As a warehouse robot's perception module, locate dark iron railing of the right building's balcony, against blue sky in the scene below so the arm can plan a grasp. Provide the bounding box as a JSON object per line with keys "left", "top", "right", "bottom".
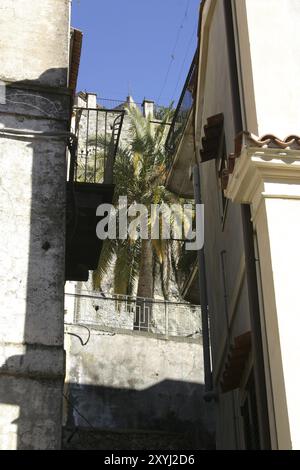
{"left": 165, "top": 54, "right": 196, "bottom": 159}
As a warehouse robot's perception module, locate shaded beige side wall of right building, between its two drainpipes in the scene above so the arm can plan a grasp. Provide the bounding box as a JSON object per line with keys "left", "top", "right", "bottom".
{"left": 197, "top": 0, "right": 251, "bottom": 449}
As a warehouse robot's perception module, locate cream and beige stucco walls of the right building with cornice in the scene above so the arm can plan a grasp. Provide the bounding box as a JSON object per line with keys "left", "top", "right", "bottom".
{"left": 197, "top": 0, "right": 300, "bottom": 449}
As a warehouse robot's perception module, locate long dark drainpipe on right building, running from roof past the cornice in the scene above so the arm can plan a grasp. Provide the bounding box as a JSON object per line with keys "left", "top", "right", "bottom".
{"left": 224, "top": 1, "right": 271, "bottom": 449}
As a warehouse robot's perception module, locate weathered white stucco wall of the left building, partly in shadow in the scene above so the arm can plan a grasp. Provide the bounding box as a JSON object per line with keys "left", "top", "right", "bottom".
{"left": 0, "top": 0, "right": 70, "bottom": 449}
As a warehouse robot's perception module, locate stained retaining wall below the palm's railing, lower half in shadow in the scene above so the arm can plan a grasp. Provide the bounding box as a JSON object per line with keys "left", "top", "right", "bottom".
{"left": 66, "top": 326, "right": 213, "bottom": 448}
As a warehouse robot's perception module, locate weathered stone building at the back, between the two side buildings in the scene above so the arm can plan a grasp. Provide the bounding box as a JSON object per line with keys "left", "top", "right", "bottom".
{"left": 64, "top": 93, "right": 214, "bottom": 450}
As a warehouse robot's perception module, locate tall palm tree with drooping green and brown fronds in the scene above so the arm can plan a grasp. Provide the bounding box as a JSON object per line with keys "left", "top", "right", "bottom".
{"left": 93, "top": 106, "right": 188, "bottom": 298}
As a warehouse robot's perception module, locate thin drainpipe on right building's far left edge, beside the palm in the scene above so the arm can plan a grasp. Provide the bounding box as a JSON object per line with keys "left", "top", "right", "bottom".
{"left": 193, "top": 165, "right": 215, "bottom": 401}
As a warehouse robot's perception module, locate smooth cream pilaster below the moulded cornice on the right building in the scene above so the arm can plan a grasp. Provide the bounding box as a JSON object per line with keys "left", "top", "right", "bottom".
{"left": 260, "top": 183, "right": 300, "bottom": 450}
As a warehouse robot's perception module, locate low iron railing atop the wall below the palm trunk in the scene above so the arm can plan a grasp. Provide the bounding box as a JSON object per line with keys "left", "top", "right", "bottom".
{"left": 66, "top": 291, "right": 201, "bottom": 338}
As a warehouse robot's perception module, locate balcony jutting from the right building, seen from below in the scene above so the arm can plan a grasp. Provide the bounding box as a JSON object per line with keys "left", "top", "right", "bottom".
{"left": 166, "top": 53, "right": 197, "bottom": 198}
